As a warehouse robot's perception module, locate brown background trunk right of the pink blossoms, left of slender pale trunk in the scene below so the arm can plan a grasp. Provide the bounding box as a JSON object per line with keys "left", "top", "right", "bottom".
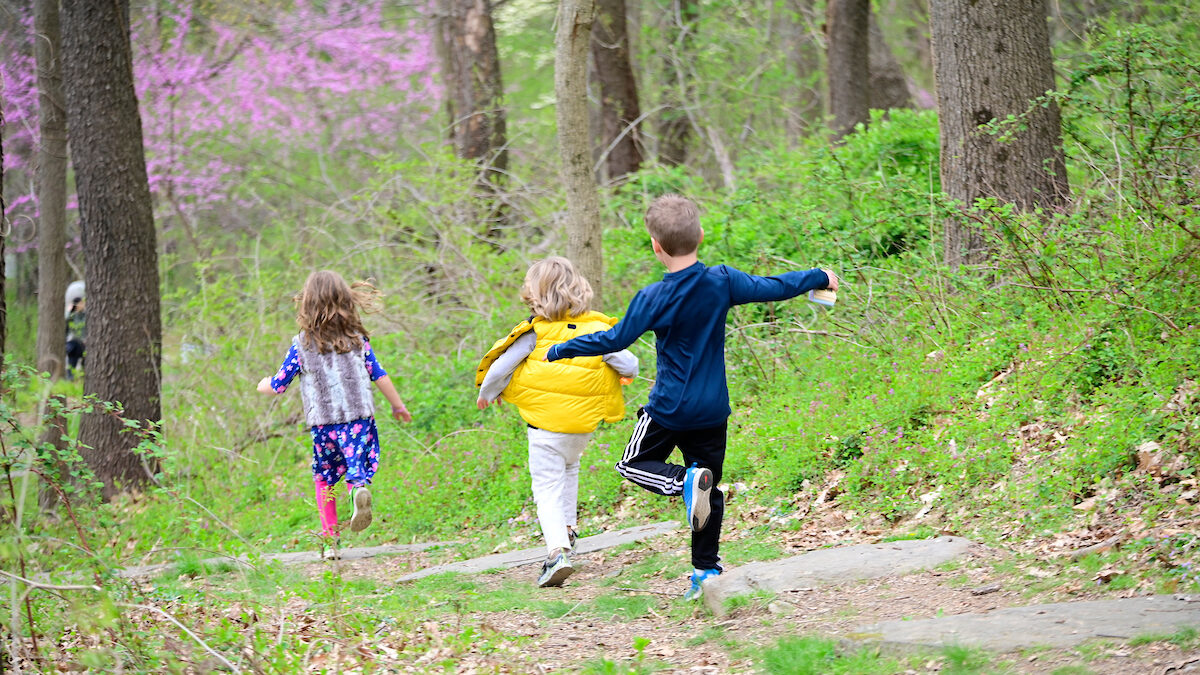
{"left": 436, "top": 0, "right": 509, "bottom": 181}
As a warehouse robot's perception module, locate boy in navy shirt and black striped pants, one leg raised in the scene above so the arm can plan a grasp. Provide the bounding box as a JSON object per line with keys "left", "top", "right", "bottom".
{"left": 546, "top": 195, "right": 838, "bottom": 599}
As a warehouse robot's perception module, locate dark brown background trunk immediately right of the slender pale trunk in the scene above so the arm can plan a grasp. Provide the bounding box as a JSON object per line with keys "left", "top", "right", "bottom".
{"left": 592, "top": 0, "right": 642, "bottom": 180}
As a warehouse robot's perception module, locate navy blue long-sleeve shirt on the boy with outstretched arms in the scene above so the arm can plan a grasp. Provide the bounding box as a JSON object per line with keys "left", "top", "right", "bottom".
{"left": 546, "top": 262, "right": 829, "bottom": 430}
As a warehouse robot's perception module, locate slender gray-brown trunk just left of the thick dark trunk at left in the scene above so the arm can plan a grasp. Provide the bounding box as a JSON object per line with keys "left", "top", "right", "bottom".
{"left": 34, "top": 0, "right": 67, "bottom": 380}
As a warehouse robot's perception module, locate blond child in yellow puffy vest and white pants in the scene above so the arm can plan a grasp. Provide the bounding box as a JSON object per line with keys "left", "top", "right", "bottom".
{"left": 475, "top": 256, "right": 637, "bottom": 586}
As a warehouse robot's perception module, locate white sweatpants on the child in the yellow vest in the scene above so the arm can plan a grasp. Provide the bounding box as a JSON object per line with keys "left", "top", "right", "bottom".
{"left": 529, "top": 426, "right": 592, "bottom": 554}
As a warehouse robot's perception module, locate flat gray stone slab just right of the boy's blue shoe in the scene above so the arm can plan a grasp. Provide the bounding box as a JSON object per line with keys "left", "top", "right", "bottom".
{"left": 702, "top": 537, "right": 971, "bottom": 616}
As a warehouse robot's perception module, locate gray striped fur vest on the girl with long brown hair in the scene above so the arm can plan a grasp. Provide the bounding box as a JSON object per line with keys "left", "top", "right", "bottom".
{"left": 292, "top": 333, "right": 374, "bottom": 426}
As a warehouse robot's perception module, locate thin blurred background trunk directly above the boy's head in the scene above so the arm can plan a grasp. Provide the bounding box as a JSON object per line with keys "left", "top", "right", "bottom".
{"left": 659, "top": 0, "right": 700, "bottom": 167}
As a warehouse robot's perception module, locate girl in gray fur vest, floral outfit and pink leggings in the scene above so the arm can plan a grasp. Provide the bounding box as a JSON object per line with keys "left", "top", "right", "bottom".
{"left": 258, "top": 270, "right": 413, "bottom": 557}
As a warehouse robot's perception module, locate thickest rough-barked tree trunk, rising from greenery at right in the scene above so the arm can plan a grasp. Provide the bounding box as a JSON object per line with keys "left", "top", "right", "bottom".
{"left": 930, "top": 0, "right": 1069, "bottom": 265}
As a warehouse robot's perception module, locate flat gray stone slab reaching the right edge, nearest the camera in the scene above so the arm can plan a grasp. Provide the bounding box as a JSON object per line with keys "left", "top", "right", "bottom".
{"left": 848, "top": 596, "right": 1200, "bottom": 652}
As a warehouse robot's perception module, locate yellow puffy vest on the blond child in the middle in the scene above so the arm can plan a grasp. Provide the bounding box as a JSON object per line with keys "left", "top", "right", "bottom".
{"left": 475, "top": 311, "right": 625, "bottom": 434}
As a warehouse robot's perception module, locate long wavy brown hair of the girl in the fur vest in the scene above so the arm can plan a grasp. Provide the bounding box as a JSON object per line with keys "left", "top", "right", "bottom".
{"left": 294, "top": 269, "right": 379, "bottom": 354}
